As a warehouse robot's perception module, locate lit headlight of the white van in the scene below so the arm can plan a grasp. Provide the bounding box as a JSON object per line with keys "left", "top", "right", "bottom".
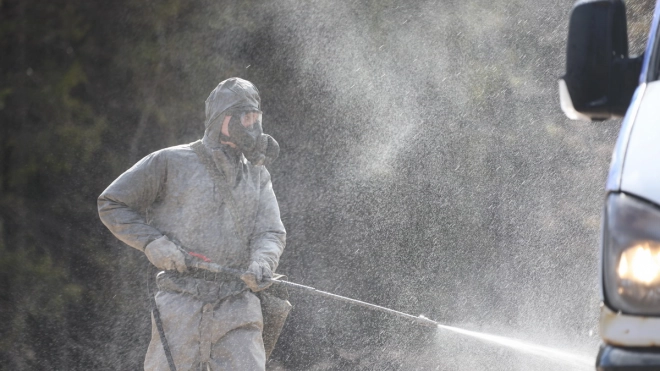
{"left": 602, "top": 193, "right": 660, "bottom": 315}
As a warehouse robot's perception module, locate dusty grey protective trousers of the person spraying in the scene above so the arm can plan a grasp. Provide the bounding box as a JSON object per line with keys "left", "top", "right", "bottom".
{"left": 144, "top": 291, "right": 266, "bottom": 371}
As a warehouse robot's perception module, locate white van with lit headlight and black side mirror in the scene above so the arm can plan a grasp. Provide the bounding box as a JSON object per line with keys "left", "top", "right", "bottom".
{"left": 559, "top": 0, "right": 660, "bottom": 370}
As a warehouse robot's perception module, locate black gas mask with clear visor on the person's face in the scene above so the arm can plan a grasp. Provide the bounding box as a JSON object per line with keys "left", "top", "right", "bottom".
{"left": 220, "top": 112, "right": 280, "bottom": 166}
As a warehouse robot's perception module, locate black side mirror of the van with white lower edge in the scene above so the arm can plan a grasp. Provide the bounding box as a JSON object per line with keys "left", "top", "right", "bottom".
{"left": 559, "top": 0, "right": 642, "bottom": 121}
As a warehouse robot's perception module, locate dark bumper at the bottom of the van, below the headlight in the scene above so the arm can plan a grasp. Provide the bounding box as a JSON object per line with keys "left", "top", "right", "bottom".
{"left": 596, "top": 345, "right": 660, "bottom": 371}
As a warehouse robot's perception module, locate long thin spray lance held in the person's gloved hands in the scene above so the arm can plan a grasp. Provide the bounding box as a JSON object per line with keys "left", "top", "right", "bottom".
{"left": 186, "top": 251, "right": 440, "bottom": 328}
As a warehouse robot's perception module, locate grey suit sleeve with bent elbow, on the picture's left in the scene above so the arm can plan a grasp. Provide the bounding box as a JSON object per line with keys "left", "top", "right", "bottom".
{"left": 98, "top": 151, "right": 167, "bottom": 251}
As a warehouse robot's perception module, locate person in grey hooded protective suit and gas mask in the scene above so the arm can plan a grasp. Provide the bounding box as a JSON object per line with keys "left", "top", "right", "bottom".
{"left": 98, "top": 78, "right": 286, "bottom": 370}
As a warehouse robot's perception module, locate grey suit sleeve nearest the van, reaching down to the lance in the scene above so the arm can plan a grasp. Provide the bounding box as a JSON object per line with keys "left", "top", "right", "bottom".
{"left": 250, "top": 167, "right": 286, "bottom": 271}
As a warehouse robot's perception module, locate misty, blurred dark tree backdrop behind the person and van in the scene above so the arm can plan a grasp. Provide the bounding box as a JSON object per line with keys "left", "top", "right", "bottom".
{"left": 0, "top": 0, "right": 653, "bottom": 370}
